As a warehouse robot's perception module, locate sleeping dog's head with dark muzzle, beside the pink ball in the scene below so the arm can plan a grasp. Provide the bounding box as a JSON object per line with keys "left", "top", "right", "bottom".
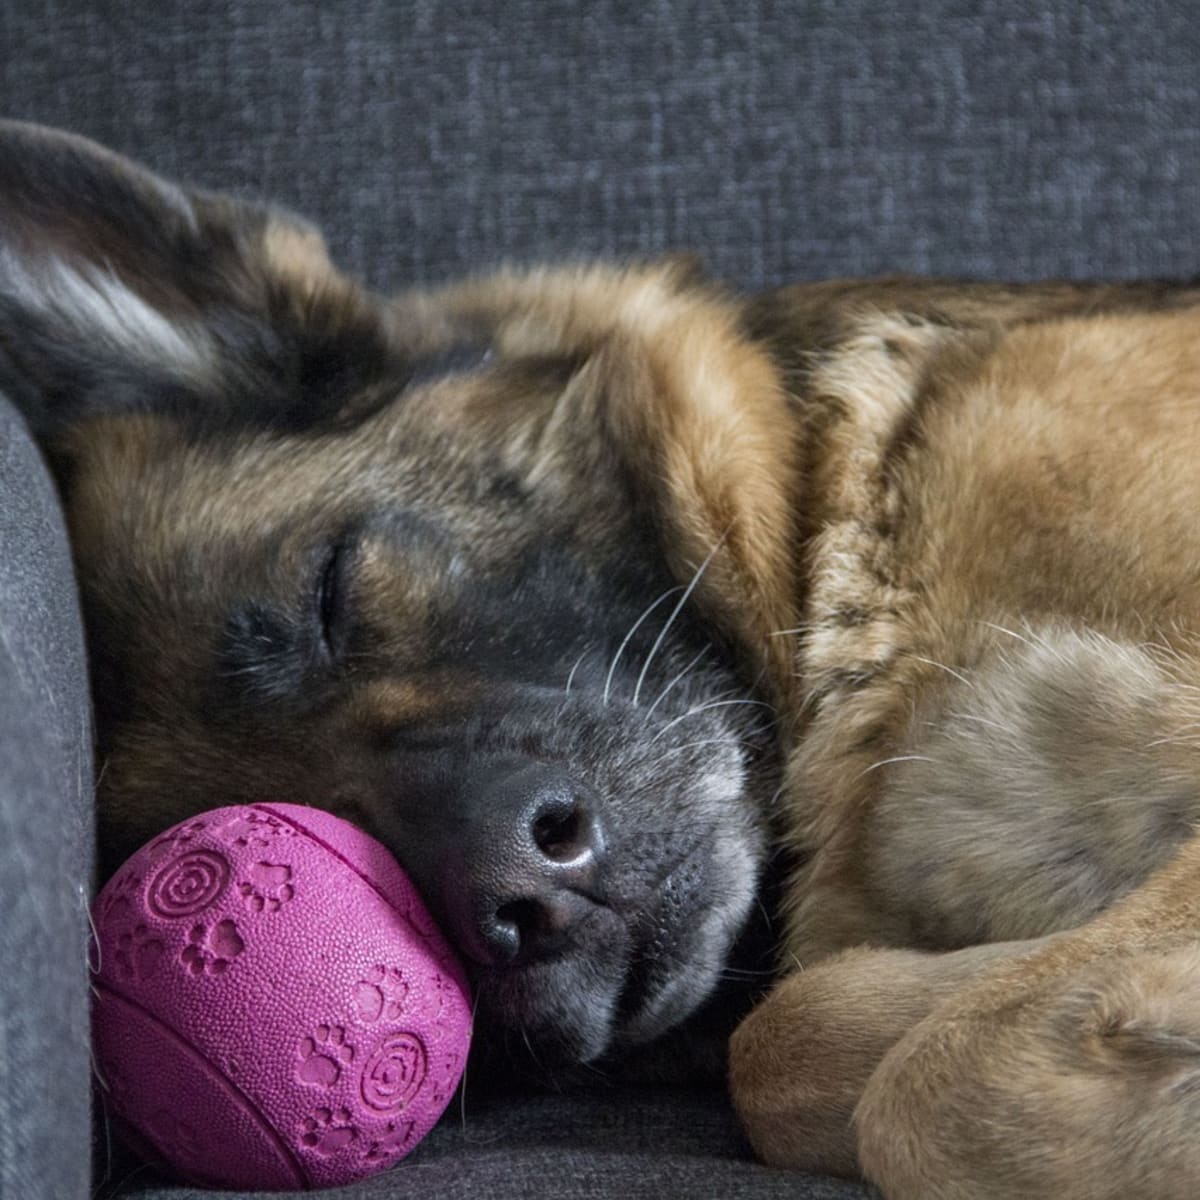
{"left": 0, "top": 125, "right": 793, "bottom": 1061}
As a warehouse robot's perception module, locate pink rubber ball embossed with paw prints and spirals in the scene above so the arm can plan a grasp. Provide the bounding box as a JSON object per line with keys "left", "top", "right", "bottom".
{"left": 92, "top": 804, "right": 470, "bottom": 1189}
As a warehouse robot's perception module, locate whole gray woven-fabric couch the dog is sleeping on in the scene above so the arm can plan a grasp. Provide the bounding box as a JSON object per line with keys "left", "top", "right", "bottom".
{"left": 0, "top": 0, "right": 1200, "bottom": 1200}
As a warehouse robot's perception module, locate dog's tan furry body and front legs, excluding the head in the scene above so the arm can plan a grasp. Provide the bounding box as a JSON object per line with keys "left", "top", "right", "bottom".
{"left": 732, "top": 285, "right": 1200, "bottom": 1200}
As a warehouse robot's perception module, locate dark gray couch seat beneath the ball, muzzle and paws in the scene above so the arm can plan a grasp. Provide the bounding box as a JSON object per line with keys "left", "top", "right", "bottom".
{"left": 100, "top": 1090, "right": 878, "bottom": 1200}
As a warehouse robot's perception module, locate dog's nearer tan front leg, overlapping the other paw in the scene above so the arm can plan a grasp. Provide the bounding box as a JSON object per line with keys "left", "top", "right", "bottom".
{"left": 854, "top": 839, "right": 1200, "bottom": 1200}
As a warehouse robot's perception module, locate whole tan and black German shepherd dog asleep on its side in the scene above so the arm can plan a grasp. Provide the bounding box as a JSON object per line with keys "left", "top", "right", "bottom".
{"left": 7, "top": 124, "right": 1200, "bottom": 1200}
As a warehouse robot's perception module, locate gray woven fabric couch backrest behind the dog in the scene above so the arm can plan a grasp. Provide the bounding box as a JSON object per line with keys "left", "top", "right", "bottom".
{"left": 0, "top": 0, "right": 1200, "bottom": 288}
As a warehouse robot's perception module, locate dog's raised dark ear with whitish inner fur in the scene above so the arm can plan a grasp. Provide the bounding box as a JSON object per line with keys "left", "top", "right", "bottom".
{"left": 0, "top": 121, "right": 403, "bottom": 434}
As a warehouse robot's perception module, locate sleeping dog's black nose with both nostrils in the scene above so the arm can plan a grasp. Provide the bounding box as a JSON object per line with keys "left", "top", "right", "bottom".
{"left": 450, "top": 763, "right": 605, "bottom": 966}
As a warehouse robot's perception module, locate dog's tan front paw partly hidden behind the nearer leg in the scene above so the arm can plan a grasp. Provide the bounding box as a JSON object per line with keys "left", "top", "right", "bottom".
{"left": 730, "top": 941, "right": 1040, "bottom": 1176}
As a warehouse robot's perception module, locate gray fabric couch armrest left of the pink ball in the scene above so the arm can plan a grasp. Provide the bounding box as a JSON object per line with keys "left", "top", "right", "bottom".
{"left": 0, "top": 397, "right": 91, "bottom": 1200}
